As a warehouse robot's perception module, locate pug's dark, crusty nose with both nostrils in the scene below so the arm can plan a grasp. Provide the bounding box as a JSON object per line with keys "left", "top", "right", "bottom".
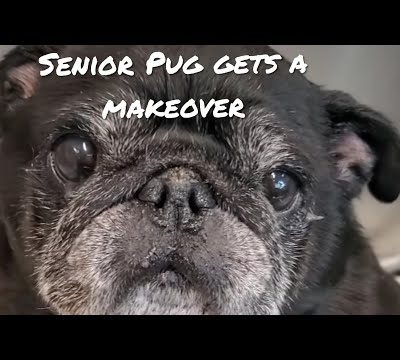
{"left": 138, "top": 168, "right": 216, "bottom": 225}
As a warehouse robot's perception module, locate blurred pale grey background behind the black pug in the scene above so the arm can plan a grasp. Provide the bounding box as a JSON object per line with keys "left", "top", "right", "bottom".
{"left": 0, "top": 45, "right": 400, "bottom": 281}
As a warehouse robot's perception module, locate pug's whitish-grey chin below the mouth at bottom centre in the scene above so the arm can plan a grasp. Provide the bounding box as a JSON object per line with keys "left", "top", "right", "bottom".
{"left": 109, "top": 270, "right": 211, "bottom": 315}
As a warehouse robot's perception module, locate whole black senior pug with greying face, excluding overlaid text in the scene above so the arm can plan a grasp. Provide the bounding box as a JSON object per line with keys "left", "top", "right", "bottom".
{"left": 0, "top": 45, "right": 400, "bottom": 315}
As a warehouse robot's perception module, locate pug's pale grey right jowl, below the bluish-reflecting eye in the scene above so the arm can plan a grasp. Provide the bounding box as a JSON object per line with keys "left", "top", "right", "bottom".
{"left": 198, "top": 211, "right": 276, "bottom": 314}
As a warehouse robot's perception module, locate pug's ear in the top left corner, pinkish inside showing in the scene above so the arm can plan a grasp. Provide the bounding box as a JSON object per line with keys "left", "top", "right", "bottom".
{"left": 0, "top": 45, "right": 62, "bottom": 111}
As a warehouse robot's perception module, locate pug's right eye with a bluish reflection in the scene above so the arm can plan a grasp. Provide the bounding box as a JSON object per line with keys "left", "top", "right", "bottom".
{"left": 264, "top": 170, "right": 300, "bottom": 211}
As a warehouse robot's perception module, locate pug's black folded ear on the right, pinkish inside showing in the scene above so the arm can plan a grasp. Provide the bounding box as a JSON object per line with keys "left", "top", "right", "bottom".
{"left": 323, "top": 91, "right": 400, "bottom": 203}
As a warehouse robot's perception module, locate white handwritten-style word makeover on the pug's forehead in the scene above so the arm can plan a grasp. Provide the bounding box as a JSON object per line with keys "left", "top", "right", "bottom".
{"left": 102, "top": 99, "right": 245, "bottom": 119}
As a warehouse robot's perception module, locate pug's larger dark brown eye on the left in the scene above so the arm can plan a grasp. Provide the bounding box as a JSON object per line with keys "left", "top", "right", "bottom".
{"left": 52, "top": 135, "right": 96, "bottom": 182}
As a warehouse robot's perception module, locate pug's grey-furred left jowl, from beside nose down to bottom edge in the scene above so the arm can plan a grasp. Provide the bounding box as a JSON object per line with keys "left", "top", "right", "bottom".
{"left": 37, "top": 204, "right": 161, "bottom": 314}
